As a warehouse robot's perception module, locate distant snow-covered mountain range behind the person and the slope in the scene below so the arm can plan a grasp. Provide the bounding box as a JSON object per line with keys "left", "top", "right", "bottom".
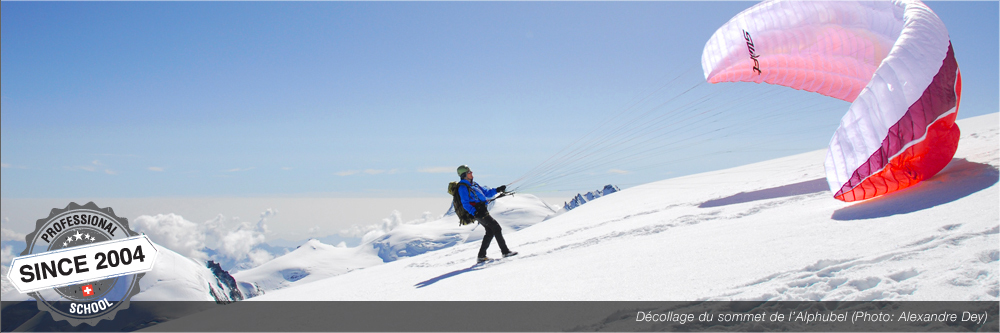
{"left": 2, "top": 185, "right": 619, "bottom": 304}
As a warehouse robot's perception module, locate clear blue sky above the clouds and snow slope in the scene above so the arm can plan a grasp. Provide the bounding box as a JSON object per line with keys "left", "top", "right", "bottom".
{"left": 0, "top": 1, "right": 1000, "bottom": 198}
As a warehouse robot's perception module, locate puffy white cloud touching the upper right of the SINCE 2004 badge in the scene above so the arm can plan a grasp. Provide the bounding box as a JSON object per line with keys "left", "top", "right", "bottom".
{"left": 132, "top": 214, "right": 208, "bottom": 260}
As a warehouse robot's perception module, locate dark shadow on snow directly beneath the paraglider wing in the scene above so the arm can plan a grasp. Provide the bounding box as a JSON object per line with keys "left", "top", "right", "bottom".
{"left": 831, "top": 158, "right": 1000, "bottom": 221}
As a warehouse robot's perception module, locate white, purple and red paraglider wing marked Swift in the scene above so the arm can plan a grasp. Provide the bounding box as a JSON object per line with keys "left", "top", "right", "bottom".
{"left": 701, "top": 0, "right": 962, "bottom": 201}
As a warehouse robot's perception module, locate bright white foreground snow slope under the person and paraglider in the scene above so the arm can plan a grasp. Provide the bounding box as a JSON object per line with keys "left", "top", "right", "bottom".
{"left": 251, "top": 114, "right": 1000, "bottom": 301}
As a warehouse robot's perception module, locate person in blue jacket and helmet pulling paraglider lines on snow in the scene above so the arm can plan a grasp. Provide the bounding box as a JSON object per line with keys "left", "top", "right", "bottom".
{"left": 458, "top": 165, "right": 517, "bottom": 262}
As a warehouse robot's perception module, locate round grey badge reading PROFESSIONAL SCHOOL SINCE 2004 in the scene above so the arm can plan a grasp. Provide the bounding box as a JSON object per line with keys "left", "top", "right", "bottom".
{"left": 9, "top": 202, "right": 156, "bottom": 326}
